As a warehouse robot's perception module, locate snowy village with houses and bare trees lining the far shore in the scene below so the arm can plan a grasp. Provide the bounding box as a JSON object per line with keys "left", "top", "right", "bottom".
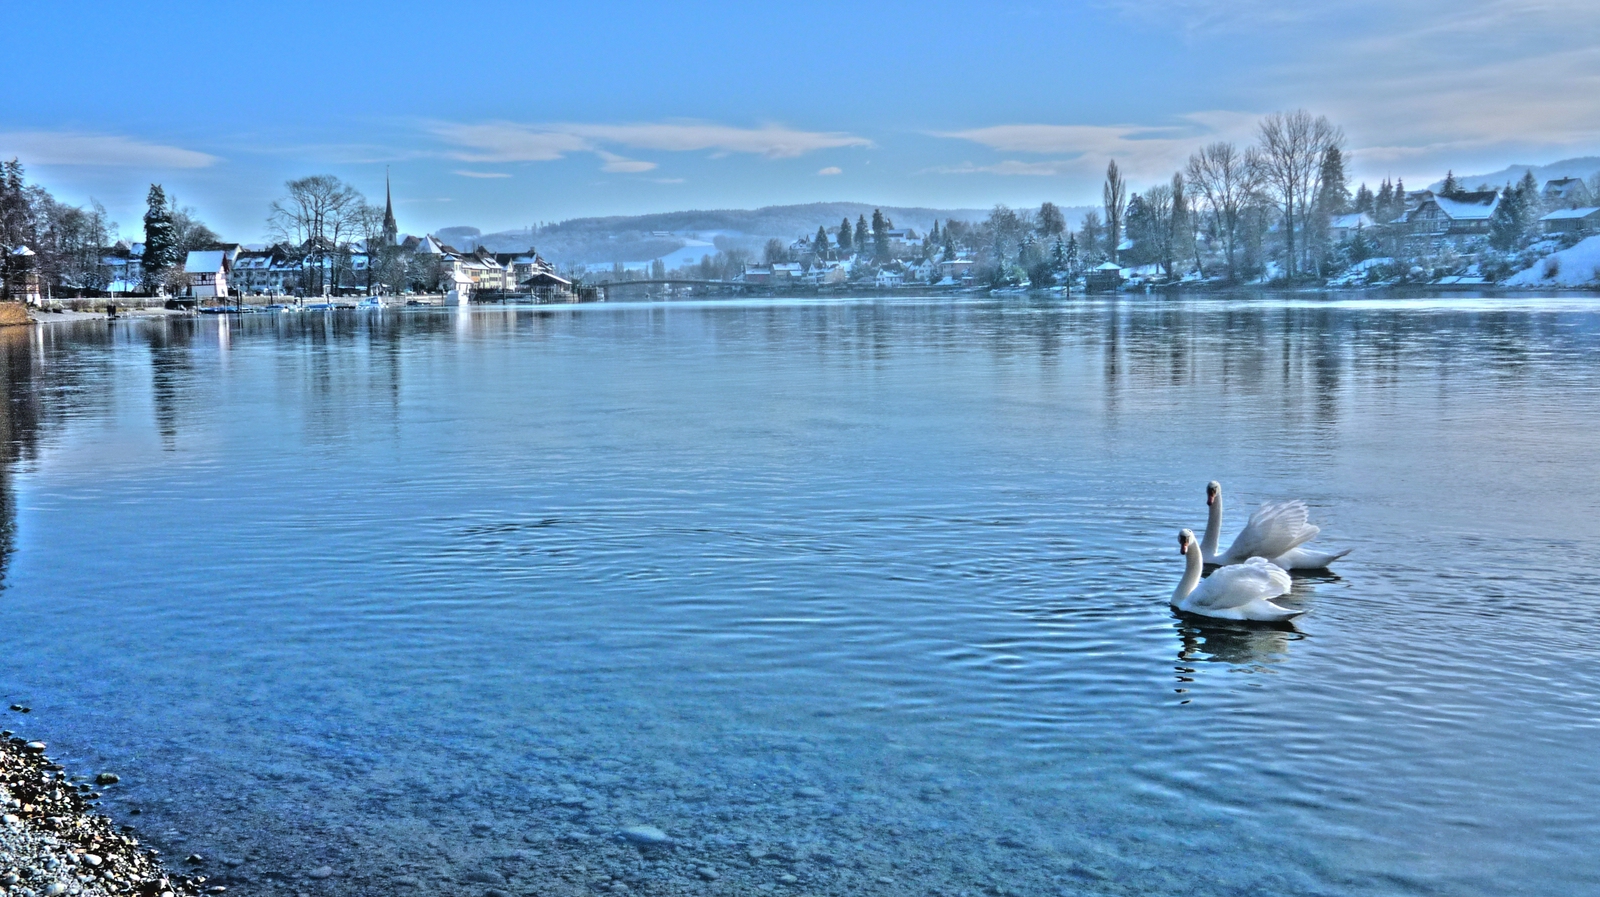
{"left": 0, "top": 110, "right": 1600, "bottom": 312}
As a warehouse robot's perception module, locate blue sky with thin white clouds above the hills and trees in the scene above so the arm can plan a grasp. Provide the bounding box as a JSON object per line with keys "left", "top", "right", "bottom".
{"left": 0, "top": 0, "right": 1600, "bottom": 241}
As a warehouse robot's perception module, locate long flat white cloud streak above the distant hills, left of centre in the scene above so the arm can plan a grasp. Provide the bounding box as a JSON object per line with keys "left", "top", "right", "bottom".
{"left": 430, "top": 122, "right": 872, "bottom": 173}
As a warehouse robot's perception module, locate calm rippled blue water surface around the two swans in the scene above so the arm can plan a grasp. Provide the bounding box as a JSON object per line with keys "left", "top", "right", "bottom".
{"left": 0, "top": 297, "right": 1600, "bottom": 895}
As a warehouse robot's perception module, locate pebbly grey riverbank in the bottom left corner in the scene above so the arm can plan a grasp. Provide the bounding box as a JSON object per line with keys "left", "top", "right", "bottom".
{"left": 0, "top": 731, "right": 201, "bottom": 897}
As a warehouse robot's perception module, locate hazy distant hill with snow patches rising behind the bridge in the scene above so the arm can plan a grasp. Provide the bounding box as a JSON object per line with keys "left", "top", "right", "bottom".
{"left": 440, "top": 203, "right": 1090, "bottom": 267}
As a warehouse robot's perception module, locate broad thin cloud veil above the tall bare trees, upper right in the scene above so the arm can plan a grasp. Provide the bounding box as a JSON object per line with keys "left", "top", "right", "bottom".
{"left": 1101, "top": 0, "right": 1600, "bottom": 174}
